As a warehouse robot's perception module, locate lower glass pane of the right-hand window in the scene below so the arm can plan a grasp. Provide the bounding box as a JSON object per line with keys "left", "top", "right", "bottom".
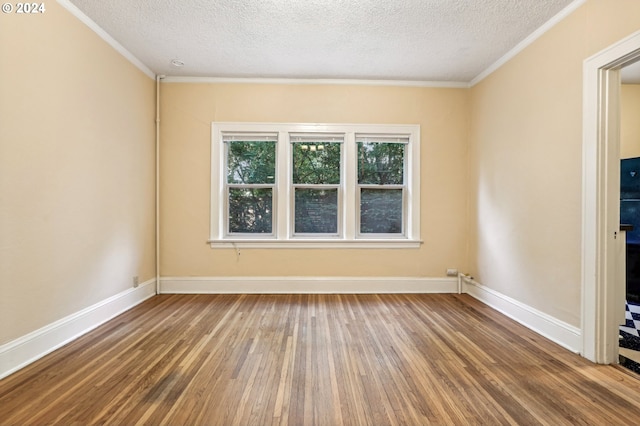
{"left": 360, "top": 188, "right": 402, "bottom": 234}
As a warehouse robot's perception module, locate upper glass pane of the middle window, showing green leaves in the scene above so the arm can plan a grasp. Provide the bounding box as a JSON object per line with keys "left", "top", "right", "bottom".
{"left": 292, "top": 142, "right": 342, "bottom": 185}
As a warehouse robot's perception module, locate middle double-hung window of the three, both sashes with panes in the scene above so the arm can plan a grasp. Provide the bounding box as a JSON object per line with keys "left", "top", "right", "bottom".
{"left": 289, "top": 134, "right": 344, "bottom": 238}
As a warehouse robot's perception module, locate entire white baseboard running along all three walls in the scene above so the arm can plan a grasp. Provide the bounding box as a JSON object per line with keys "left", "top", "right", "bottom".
{"left": 0, "top": 277, "right": 582, "bottom": 379}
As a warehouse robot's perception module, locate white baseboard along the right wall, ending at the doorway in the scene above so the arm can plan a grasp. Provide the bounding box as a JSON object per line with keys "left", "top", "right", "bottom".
{"left": 463, "top": 278, "right": 582, "bottom": 353}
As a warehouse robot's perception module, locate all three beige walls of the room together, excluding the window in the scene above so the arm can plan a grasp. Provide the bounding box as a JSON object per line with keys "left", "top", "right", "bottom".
{"left": 5, "top": 0, "right": 640, "bottom": 350}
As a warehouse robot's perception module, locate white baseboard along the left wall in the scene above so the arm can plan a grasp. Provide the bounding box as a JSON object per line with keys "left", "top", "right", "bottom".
{"left": 0, "top": 278, "right": 156, "bottom": 379}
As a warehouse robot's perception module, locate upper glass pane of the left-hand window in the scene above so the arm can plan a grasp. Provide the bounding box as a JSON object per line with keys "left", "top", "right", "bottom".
{"left": 227, "top": 141, "right": 276, "bottom": 184}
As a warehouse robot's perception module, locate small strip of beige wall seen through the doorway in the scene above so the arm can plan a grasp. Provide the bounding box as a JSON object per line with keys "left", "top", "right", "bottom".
{"left": 620, "top": 84, "right": 640, "bottom": 158}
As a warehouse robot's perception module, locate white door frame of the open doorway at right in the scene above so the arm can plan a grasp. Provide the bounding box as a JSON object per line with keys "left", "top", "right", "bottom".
{"left": 581, "top": 31, "right": 640, "bottom": 364}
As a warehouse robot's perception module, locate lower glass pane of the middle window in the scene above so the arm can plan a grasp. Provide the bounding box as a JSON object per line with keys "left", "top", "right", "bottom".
{"left": 294, "top": 188, "right": 338, "bottom": 234}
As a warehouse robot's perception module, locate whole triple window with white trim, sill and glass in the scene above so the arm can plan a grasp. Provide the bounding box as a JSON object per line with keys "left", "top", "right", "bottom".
{"left": 209, "top": 123, "right": 420, "bottom": 248}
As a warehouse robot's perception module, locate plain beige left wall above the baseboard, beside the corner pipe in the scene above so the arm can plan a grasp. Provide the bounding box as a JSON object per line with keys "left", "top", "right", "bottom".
{"left": 0, "top": 2, "right": 155, "bottom": 344}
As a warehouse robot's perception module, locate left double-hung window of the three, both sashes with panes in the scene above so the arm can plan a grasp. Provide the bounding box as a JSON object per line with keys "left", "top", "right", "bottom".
{"left": 223, "top": 134, "right": 277, "bottom": 236}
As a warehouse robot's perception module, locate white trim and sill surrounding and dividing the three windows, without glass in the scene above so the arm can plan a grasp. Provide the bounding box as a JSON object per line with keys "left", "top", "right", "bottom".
{"left": 208, "top": 122, "right": 422, "bottom": 248}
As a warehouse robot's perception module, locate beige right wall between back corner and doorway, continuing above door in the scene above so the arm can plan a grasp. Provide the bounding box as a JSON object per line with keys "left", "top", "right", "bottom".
{"left": 470, "top": 0, "right": 640, "bottom": 326}
